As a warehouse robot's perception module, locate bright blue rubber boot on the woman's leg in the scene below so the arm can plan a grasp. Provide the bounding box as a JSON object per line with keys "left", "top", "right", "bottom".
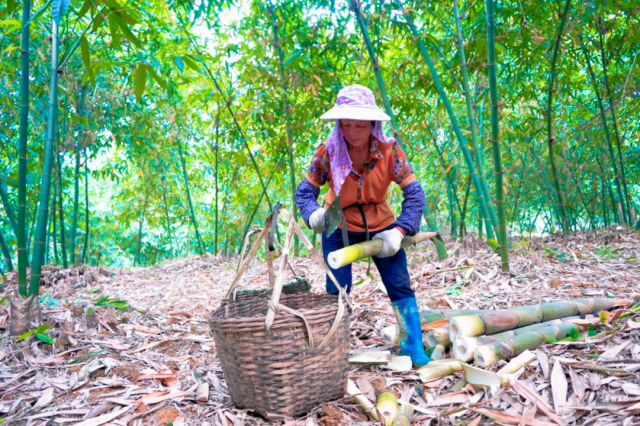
{"left": 393, "top": 297, "right": 431, "bottom": 367}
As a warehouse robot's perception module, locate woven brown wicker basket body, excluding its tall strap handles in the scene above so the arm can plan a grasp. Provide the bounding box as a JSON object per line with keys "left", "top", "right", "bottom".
{"left": 209, "top": 294, "right": 349, "bottom": 418}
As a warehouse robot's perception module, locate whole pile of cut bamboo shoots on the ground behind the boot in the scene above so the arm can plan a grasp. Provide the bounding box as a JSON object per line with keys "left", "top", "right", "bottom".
{"left": 382, "top": 298, "right": 633, "bottom": 367}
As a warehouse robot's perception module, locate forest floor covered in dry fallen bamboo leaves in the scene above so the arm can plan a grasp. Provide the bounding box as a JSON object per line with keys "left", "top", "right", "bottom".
{"left": 0, "top": 229, "right": 640, "bottom": 426}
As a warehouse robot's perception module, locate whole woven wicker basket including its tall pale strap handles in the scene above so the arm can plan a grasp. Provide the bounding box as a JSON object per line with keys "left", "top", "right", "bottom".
{"left": 209, "top": 209, "right": 350, "bottom": 419}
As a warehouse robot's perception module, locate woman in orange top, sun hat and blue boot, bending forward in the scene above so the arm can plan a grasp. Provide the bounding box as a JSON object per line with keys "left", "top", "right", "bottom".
{"left": 296, "top": 84, "right": 431, "bottom": 366}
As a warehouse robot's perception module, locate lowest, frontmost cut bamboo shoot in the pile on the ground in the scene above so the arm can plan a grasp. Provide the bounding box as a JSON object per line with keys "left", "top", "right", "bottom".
{"left": 474, "top": 323, "right": 579, "bottom": 368}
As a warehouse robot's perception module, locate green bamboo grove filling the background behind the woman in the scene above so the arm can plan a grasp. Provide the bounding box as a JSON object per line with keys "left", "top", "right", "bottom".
{"left": 0, "top": 0, "right": 640, "bottom": 290}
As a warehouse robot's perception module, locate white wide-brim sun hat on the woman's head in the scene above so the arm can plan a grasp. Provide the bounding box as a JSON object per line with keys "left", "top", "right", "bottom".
{"left": 320, "top": 84, "right": 391, "bottom": 121}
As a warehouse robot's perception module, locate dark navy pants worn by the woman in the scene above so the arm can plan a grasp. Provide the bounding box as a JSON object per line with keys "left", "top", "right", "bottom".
{"left": 322, "top": 225, "right": 415, "bottom": 302}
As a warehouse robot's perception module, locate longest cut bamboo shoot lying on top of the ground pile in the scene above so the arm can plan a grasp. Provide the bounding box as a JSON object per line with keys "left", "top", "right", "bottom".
{"left": 449, "top": 298, "right": 633, "bottom": 341}
